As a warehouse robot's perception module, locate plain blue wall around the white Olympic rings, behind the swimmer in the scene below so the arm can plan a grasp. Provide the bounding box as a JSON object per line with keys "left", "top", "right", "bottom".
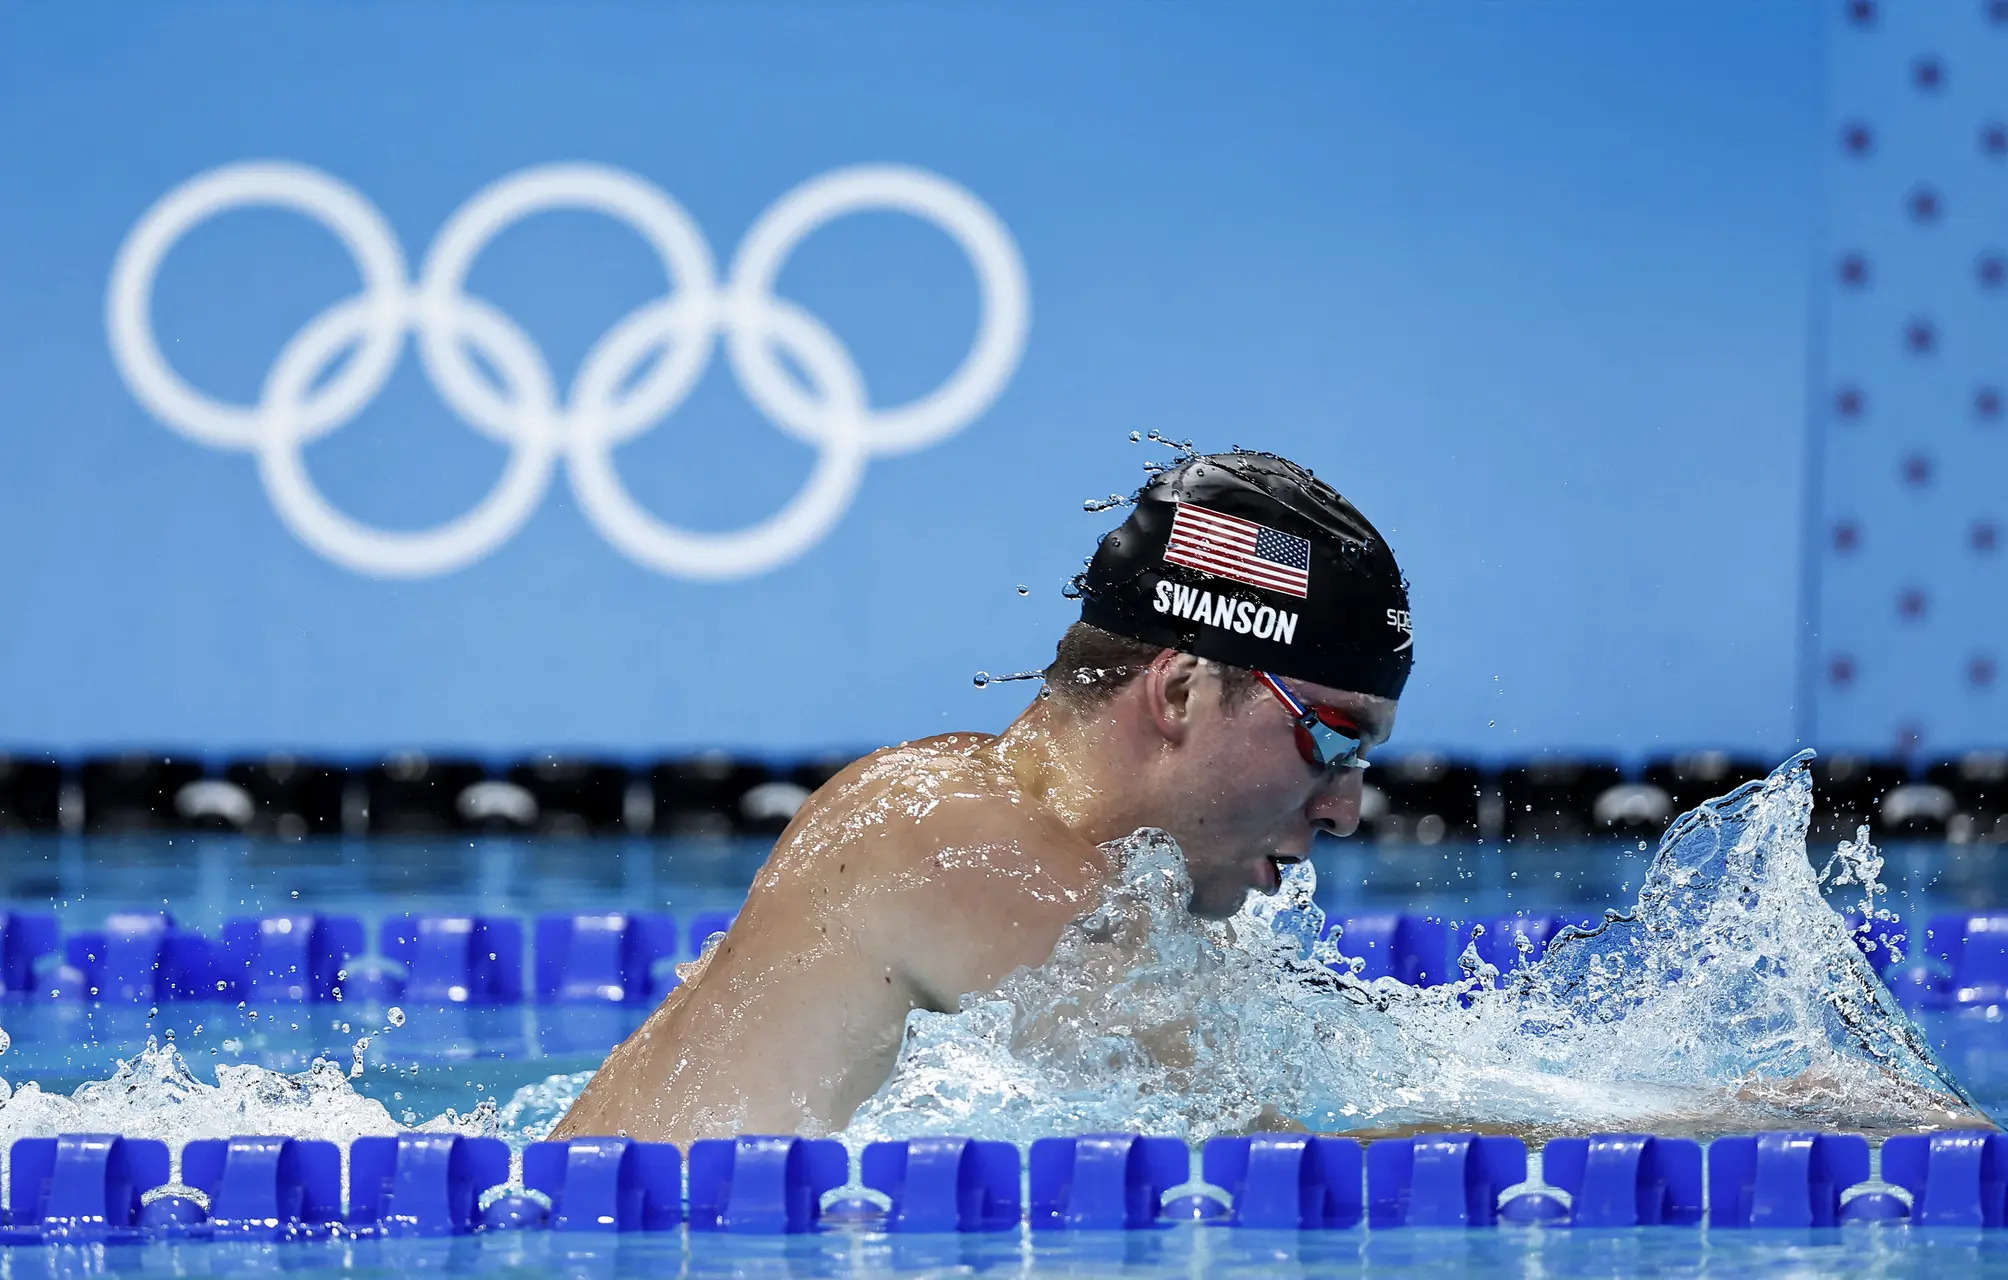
{"left": 0, "top": 0, "right": 1998, "bottom": 758}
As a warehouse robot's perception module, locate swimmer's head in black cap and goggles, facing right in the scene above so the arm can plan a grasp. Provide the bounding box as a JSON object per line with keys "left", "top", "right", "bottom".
{"left": 1046, "top": 452, "right": 1412, "bottom": 916}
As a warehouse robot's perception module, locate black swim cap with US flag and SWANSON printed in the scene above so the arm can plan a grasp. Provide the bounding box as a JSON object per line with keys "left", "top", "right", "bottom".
{"left": 1076, "top": 450, "right": 1416, "bottom": 697}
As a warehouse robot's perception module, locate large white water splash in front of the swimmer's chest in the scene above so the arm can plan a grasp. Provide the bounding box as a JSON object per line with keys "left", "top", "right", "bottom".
{"left": 845, "top": 752, "right": 1972, "bottom": 1141}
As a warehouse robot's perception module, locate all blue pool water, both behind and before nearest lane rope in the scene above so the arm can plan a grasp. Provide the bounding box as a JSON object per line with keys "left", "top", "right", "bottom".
{"left": 0, "top": 823, "right": 2008, "bottom": 1280}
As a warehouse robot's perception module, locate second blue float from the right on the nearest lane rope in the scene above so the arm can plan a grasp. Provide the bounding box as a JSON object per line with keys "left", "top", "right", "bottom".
{"left": 1709, "top": 1133, "right": 1869, "bottom": 1228}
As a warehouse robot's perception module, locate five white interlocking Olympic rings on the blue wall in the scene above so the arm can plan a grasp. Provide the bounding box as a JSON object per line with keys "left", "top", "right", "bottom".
{"left": 106, "top": 163, "right": 1030, "bottom": 579}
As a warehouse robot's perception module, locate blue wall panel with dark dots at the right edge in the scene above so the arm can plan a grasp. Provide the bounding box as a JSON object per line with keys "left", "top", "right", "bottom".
{"left": 1803, "top": 2, "right": 2008, "bottom": 754}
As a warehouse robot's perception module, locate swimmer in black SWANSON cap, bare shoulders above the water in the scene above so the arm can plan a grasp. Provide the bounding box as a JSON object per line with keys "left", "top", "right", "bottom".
{"left": 552, "top": 452, "right": 1414, "bottom": 1145}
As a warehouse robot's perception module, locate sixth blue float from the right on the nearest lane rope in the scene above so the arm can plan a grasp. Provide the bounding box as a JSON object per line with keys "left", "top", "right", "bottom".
{"left": 1030, "top": 1133, "right": 1193, "bottom": 1232}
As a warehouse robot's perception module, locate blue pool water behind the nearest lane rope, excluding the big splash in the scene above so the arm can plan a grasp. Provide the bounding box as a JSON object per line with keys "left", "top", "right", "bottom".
{"left": 0, "top": 836, "right": 2008, "bottom": 1121}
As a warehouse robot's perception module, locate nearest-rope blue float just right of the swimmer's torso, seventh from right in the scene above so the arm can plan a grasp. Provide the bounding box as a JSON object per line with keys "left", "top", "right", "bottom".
{"left": 859, "top": 1137, "right": 1022, "bottom": 1232}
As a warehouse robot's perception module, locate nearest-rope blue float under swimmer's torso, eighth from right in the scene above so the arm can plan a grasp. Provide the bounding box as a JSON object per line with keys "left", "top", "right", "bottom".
{"left": 691, "top": 1135, "right": 851, "bottom": 1236}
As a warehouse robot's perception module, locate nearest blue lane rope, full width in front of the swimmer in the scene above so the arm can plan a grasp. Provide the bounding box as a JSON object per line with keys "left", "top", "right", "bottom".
{"left": 0, "top": 1129, "right": 2008, "bottom": 1246}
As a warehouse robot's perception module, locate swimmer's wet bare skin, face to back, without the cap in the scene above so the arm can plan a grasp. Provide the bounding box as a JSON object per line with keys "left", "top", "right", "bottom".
{"left": 552, "top": 651, "right": 1396, "bottom": 1143}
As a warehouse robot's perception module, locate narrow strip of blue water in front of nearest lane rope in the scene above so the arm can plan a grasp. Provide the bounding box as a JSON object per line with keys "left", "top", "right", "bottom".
{"left": 11, "top": 1226, "right": 2008, "bottom": 1280}
